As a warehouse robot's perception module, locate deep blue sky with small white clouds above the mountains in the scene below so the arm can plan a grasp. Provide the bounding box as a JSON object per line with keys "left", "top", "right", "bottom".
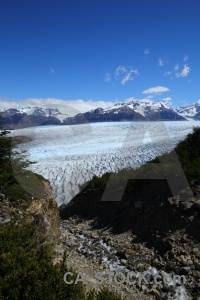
{"left": 0, "top": 0, "right": 200, "bottom": 110}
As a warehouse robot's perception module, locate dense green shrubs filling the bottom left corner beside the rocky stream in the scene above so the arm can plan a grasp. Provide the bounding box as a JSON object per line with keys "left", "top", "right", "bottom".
{"left": 0, "top": 217, "right": 120, "bottom": 300}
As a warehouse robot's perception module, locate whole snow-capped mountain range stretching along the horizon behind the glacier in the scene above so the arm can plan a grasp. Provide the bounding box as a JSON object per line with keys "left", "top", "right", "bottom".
{"left": 0, "top": 100, "right": 200, "bottom": 129}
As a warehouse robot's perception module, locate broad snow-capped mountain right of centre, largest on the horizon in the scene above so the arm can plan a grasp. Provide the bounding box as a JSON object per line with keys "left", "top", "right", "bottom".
{"left": 63, "top": 100, "right": 185, "bottom": 125}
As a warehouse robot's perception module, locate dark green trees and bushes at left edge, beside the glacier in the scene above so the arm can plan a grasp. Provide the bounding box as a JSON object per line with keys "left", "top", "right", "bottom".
{"left": 0, "top": 126, "right": 45, "bottom": 202}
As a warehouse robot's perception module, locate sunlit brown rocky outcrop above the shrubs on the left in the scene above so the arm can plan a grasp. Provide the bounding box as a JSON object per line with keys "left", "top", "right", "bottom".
{"left": 0, "top": 180, "right": 60, "bottom": 245}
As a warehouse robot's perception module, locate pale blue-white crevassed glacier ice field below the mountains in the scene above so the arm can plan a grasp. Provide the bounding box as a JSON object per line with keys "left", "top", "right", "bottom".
{"left": 12, "top": 121, "right": 200, "bottom": 205}
